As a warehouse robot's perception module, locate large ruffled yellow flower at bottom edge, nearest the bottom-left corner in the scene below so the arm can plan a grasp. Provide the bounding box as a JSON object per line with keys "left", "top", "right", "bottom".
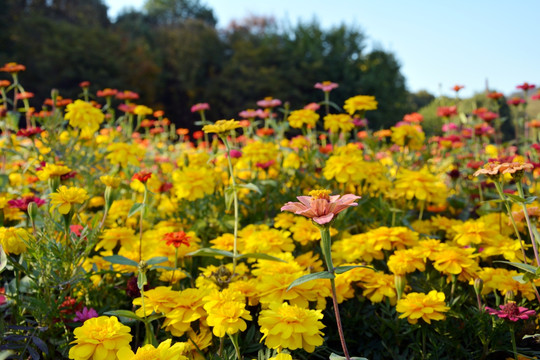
{"left": 69, "top": 316, "right": 132, "bottom": 360}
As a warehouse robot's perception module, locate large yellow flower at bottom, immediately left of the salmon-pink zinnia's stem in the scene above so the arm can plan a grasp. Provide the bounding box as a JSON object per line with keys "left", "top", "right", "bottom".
{"left": 259, "top": 303, "right": 324, "bottom": 352}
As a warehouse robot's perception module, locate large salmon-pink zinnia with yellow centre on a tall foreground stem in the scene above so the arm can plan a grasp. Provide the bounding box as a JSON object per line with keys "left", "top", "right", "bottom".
{"left": 281, "top": 190, "right": 360, "bottom": 225}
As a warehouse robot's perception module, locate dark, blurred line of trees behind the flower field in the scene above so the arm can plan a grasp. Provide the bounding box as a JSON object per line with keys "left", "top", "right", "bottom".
{"left": 0, "top": 0, "right": 431, "bottom": 128}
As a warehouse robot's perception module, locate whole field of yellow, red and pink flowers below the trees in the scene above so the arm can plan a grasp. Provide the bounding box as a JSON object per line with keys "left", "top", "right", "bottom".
{"left": 0, "top": 63, "right": 540, "bottom": 360}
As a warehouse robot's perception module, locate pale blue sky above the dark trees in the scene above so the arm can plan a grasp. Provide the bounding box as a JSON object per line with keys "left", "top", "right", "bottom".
{"left": 104, "top": 0, "right": 540, "bottom": 96}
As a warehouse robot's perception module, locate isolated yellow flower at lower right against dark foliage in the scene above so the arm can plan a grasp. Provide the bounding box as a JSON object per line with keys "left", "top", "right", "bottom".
{"left": 396, "top": 290, "right": 450, "bottom": 324}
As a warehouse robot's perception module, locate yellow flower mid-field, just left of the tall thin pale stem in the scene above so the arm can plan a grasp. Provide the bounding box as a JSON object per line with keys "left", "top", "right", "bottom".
{"left": 172, "top": 166, "right": 216, "bottom": 201}
